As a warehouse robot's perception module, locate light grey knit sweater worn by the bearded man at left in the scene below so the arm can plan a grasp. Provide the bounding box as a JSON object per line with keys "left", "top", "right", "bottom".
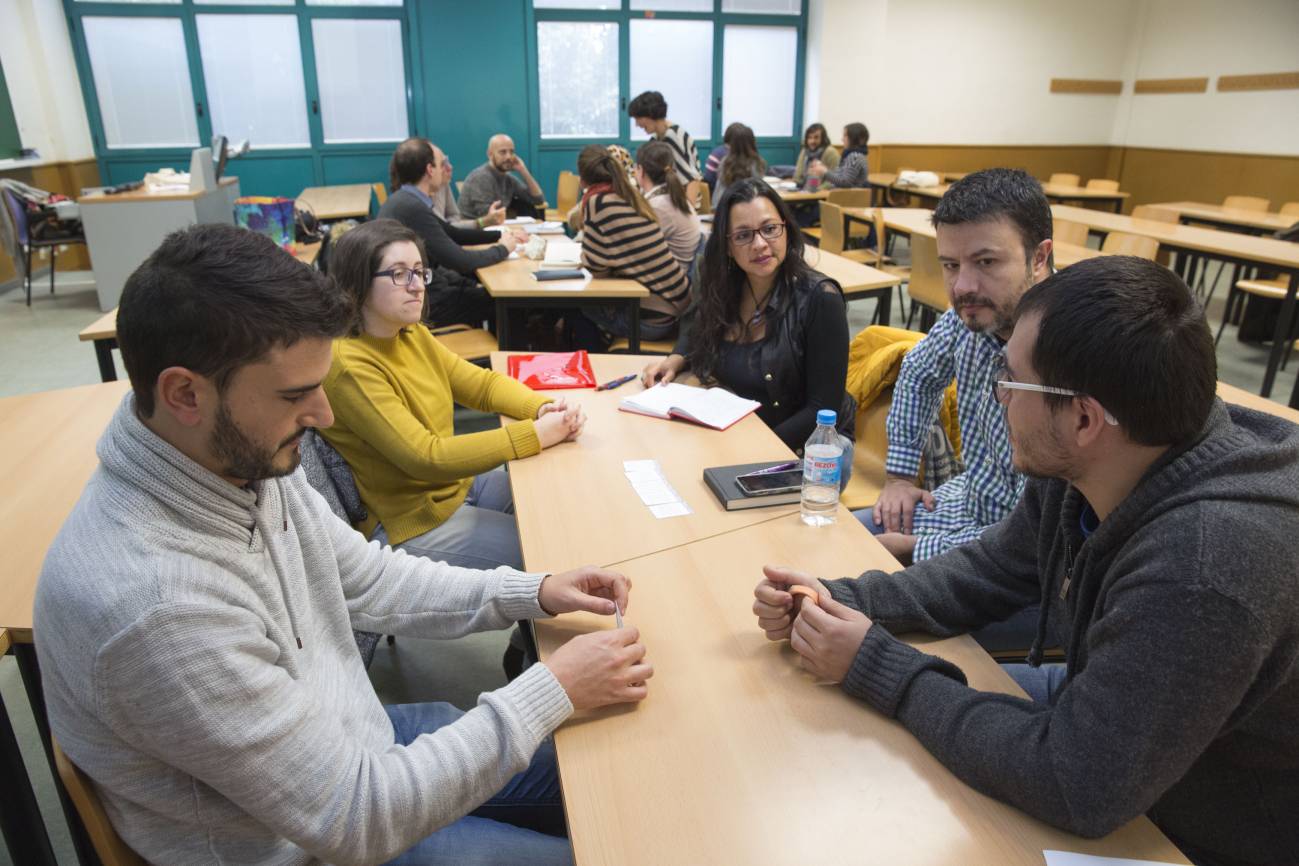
{"left": 35, "top": 395, "right": 572, "bottom": 865}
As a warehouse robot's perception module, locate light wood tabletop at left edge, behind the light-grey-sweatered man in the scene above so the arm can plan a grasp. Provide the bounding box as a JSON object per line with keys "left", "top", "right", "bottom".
{"left": 0, "top": 382, "right": 130, "bottom": 643}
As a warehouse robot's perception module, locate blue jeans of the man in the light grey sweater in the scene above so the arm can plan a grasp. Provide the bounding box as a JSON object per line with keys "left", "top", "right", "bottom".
{"left": 383, "top": 702, "right": 573, "bottom": 866}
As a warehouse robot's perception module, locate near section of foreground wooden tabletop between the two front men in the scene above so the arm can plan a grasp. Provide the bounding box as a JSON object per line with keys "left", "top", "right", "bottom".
{"left": 537, "top": 511, "right": 1187, "bottom": 866}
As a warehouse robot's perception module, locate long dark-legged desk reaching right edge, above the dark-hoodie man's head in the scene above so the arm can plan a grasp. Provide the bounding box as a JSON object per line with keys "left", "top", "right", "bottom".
{"left": 1051, "top": 205, "right": 1299, "bottom": 408}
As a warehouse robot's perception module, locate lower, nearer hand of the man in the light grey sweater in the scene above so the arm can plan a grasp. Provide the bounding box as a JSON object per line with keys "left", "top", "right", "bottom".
{"left": 546, "top": 627, "right": 653, "bottom": 710}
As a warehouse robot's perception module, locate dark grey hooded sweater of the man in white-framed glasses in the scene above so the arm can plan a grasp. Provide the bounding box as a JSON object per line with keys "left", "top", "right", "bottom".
{"left": 826, "top": 401, "right": 1299, "bottom": 865}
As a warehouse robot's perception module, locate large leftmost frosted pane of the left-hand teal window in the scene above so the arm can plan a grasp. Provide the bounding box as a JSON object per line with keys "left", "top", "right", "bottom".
{"left": 82, "top": 17, "right": 199, "bottom": 148}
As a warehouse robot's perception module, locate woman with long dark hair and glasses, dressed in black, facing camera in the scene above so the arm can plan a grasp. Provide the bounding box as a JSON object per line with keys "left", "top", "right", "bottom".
{"left": 642, "top": 179, "right": 856, "bottom": 454}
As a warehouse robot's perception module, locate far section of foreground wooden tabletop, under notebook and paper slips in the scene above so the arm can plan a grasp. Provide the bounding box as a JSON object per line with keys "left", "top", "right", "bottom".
{"left": 491, "top": 352, "right": 799, "bottom": 571}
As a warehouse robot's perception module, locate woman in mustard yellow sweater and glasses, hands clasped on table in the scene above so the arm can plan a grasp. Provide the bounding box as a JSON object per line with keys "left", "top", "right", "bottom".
{"left": 321, "top": 219, "right": 586, "bottom": 569}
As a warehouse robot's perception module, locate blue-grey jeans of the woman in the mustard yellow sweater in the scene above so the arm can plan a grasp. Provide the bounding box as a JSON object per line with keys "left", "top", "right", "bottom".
{"left": 370, "top": 469, "right": 523, "bottom": 569}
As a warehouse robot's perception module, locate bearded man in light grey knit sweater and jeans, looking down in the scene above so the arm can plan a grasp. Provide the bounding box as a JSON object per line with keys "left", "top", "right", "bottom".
{"left": 35, "top": 226, "right": 652, "bottom": 866}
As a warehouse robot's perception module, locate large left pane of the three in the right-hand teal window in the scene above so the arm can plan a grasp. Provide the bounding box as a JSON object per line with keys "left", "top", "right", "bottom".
{"left": 536, "top": 21, "right": 621, "bottom": 139}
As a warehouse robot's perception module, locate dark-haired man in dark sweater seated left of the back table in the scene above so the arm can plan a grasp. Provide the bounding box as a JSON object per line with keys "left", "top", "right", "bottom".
{"left": 378, "top": 138, "right": 525, "bottom": 326}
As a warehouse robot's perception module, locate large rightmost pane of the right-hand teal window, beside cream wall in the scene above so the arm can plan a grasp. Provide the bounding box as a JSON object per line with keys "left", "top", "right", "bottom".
{"left": 722, "top": 25, "right": 799, "bottom": 135}
